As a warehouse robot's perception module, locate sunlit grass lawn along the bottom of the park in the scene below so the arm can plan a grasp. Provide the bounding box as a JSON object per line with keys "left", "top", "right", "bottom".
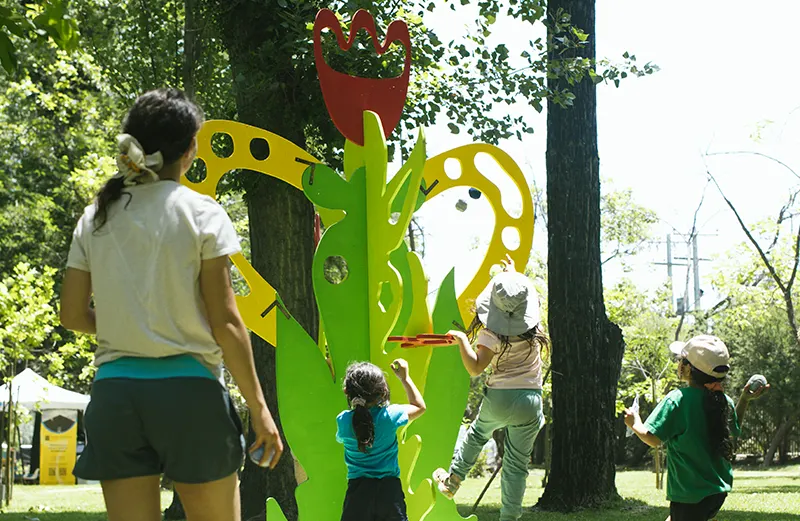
{"left": 0, "top": 467, "right": 800, "bottom": 521}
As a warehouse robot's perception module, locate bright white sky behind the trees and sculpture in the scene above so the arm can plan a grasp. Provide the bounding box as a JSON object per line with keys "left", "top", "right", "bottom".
{"left": 410, "top": 0, "right": 800, "bottom": 307}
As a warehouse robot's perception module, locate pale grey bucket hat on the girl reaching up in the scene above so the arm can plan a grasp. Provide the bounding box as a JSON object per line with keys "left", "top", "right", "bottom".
{"left": 475, "top": 271, "right": 541, "bottom": 336}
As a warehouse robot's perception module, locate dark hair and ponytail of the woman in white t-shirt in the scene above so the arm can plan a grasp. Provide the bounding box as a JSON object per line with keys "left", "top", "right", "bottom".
{"left": 94, "top": 88, "right": 203, "bottom": 231}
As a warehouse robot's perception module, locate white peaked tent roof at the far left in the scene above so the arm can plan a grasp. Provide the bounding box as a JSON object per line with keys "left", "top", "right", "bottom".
{"left": 0, "top": 369, "right": 89, "bottom": 411}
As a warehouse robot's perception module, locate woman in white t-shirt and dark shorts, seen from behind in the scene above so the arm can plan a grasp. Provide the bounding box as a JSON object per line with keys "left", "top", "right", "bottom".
{"left": 61, "top": 89, "right": 283, "bottom": 521}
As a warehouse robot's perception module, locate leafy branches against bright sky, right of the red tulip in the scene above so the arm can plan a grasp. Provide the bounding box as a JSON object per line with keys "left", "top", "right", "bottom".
{"left": 406, "top": 0, "right": 658, "bottom": 143}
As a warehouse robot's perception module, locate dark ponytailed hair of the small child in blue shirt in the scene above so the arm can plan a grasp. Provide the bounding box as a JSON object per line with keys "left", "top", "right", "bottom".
{"left": 344, "top": 362, "right": 389, "bottom": 452}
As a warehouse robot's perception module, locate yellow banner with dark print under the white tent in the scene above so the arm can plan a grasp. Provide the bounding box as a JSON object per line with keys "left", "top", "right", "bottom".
{"left": 39, "top": 410, "right": 78, "bottom": 485}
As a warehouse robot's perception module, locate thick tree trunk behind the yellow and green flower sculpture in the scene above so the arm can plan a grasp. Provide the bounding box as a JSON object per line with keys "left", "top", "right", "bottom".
{"left": 217, "top": 0, "right": 322, "bottom": 521}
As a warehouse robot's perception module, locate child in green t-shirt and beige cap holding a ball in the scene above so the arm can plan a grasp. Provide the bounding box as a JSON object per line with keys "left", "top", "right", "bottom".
{"left": 625, "top": 335, "right": 769, "bottom": 521}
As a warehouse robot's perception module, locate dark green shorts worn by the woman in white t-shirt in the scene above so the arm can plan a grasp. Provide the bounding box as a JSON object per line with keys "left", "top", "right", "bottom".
{"left": 74, "top": 378, "right": 244, "bottom": 483}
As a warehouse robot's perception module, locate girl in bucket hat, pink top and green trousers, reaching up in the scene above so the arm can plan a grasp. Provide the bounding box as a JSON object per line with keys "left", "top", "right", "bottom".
{"left": 433, "top": 258, "right": 549, "bottom": 521}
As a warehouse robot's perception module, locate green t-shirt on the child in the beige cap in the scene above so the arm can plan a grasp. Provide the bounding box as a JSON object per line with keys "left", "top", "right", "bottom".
{"left": 644, "top": 387, "right": 741, "bottom": 503}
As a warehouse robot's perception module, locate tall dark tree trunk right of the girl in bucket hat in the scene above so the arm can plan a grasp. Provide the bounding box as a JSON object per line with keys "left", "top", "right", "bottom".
{"left": 538, "top": 0, "right": 624, "bottom": 511}
